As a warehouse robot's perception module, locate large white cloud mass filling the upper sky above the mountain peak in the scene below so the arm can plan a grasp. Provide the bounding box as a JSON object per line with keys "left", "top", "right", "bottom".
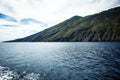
{"left": 0, "top": 0, "right": 120, "bottom": 39}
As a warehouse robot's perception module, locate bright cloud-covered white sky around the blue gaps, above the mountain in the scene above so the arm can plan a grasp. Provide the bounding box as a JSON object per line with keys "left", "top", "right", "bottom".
{"left": 0, "top": 0, "right": 120, "bottom": 41}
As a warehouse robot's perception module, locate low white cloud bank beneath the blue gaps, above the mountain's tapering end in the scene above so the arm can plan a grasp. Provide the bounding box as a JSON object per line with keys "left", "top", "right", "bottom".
{"left": 0, "top": 24, "right": 46, "bottom": 41}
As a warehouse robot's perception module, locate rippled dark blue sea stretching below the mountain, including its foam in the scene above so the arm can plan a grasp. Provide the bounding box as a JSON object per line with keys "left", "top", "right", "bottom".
{"left": 0, "top": 42, "right": 120, "bottom": 80}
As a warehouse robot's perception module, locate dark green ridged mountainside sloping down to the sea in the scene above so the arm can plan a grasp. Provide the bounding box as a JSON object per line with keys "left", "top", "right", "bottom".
{"left": 8, "top": 7, "right": 120, "bottom": 42}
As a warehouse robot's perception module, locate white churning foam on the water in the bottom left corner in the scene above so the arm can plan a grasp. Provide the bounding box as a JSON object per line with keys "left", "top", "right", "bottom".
{"left": 0, "top": 66, "right": 40, "bottom": 80}
